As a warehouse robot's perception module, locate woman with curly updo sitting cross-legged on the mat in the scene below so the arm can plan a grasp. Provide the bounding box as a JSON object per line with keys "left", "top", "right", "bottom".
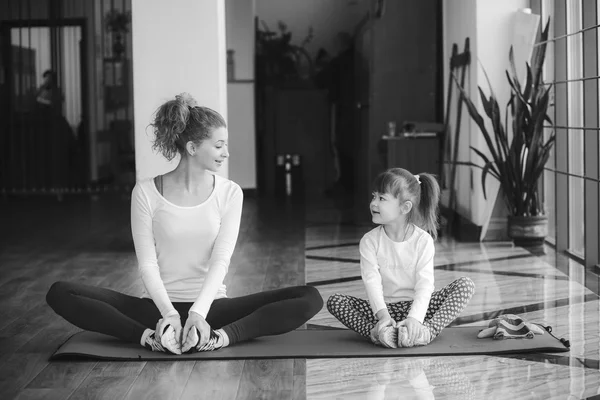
{"left": 46, "top": 94, "right": 323, "bottom": 354}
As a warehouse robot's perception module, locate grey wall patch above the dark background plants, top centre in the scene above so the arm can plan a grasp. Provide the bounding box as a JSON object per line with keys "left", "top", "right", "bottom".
{"left": 256, "top": 0, "right": 368, "bottom": 57}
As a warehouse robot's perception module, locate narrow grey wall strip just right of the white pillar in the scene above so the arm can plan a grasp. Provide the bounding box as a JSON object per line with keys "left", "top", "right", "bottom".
{"left": 225, "top": 0, "right": 256, "bottom": 189}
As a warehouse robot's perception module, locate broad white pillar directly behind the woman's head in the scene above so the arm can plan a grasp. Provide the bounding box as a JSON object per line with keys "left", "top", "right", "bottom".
{"left": 132, "top": 0, "right": 228, "bottom": 179}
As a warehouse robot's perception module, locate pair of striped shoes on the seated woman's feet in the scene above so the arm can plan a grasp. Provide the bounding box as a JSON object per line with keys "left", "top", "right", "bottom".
{"left": 144, "top": 325, "right": 225, "bottom": 354}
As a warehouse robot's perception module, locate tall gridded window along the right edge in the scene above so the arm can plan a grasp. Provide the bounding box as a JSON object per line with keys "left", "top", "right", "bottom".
{"left": 531, "top": 0, "right": 600, "bottom": 268}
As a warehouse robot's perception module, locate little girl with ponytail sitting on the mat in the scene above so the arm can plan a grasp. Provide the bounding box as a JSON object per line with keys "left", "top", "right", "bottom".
{"left": 327, "top": 168, "right": 475, "bottom": 348}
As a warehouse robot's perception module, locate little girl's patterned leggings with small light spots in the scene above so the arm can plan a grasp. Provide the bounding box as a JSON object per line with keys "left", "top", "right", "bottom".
{"left": 327, "top": 277, "right": 475, "bottom": 339}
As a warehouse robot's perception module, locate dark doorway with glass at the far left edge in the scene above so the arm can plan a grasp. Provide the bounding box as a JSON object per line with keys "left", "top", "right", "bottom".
{"left": 0, "top": 19, "right": 89, "bottom": 193}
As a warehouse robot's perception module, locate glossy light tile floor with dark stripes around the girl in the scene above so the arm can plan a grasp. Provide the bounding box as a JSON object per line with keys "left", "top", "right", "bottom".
{"left": 305, "top": 198, "right": 600, "bottom": 399}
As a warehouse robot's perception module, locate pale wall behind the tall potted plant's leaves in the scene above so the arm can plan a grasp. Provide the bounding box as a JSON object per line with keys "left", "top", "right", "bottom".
{"left": 443, "top": 0, "right": 530, "bottom": 238}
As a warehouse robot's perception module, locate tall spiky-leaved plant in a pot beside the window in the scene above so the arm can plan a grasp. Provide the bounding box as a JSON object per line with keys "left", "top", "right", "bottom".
{"left": 454, "top": 19, "right": 555, "bottom": 246}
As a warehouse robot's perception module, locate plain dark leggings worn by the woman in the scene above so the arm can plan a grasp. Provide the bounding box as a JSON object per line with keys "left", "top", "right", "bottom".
{"left": 46, "top": 282, "right": 323, "bottom": 343}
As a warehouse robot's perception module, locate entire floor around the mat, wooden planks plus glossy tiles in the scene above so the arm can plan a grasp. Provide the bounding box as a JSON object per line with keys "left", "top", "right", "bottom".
{"left": 0, "top": 194, "right": 600, "bottom": 399}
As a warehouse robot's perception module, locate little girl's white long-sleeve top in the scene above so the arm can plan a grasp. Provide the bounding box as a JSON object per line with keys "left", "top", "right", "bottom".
{"left": 359, "top": 225, "right": 435, "bottom": 323}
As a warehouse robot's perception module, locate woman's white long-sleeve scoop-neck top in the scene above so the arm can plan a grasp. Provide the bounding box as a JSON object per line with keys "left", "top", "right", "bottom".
{"left": 131, "top": 175, "right": 243, "bottom": 318}
